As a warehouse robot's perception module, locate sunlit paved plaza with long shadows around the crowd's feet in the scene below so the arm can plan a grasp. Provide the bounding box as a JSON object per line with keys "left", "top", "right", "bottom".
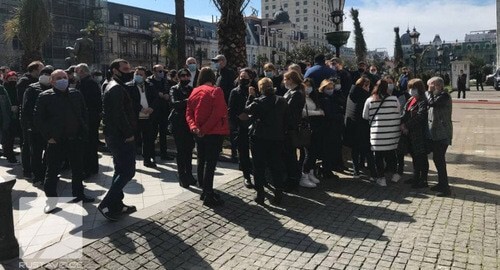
{"left": 0, "top": 87, "right": 500, "bottom": 270}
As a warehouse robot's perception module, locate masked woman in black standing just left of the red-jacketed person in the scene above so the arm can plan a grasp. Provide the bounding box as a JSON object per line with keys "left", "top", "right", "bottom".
{"left": 168, "top": 68, "right": 196, "bottom": 188}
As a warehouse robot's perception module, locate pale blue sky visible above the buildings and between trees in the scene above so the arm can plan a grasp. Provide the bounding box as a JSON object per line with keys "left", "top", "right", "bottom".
{"left": 109, "top": 0, "right": 496, "bottom": 55}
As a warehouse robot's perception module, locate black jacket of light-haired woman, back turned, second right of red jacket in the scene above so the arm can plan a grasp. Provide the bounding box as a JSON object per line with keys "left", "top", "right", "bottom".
{"left": 245, "top": 95, "right": 289, "bottom": 141}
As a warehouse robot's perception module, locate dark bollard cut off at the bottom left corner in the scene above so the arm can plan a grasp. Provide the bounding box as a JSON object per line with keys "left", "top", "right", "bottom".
{"left": 0, "top": 177, "right": 19, "bottom": 261}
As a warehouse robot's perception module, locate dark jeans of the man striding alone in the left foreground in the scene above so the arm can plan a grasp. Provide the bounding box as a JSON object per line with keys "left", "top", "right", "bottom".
{"left": 100, "top": 136, "right": 135, "bottom": 212}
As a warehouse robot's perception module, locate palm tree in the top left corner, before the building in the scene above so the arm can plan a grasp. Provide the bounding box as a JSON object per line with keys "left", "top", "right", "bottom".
{"left": 3, "top": 0, "right": 52, "bottom": 68}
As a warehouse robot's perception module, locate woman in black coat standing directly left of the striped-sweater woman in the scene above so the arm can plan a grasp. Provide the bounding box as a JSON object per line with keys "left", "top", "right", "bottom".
{"left": 344, "top": 77, "right": 375, "bottom": 178}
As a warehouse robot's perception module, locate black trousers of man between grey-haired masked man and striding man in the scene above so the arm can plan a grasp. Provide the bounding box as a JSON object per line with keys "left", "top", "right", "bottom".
{"left": 83, "top": 119, "right": 100, "bottom": 174}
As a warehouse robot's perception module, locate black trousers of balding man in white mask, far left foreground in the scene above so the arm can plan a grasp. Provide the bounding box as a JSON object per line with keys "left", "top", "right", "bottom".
{"left": 43, "top": 139, "right": 83, "bottom": 197}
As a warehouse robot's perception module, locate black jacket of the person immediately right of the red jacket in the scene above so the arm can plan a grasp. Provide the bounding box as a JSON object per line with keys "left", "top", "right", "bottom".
{"left": 227, "top": 86, "right": 249, "bottom": 131}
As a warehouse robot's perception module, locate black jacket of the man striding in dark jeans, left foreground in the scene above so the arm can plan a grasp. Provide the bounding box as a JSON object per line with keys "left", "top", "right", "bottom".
{"left": 103, "top": 80, "right": 137, "bottom": 140}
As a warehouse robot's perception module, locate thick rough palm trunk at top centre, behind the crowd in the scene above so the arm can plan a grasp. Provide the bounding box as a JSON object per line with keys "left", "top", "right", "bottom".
{"left": 212, "top": 0, "right": 250, "bottom": 69}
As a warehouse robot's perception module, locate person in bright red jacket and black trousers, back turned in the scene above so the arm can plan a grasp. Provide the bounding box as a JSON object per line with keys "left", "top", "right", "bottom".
{"left": 186, "top": 67, "right": 229, "bottom": 207}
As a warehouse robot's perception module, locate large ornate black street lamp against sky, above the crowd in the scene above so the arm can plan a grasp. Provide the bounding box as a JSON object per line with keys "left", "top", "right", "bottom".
{"left": 325, "top": 0, "right": 351, "bottom": 57}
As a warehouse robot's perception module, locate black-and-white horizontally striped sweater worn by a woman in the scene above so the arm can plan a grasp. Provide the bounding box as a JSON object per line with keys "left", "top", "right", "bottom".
{"left": 363, "top": 96, "right": 401, "bottom": 151}
